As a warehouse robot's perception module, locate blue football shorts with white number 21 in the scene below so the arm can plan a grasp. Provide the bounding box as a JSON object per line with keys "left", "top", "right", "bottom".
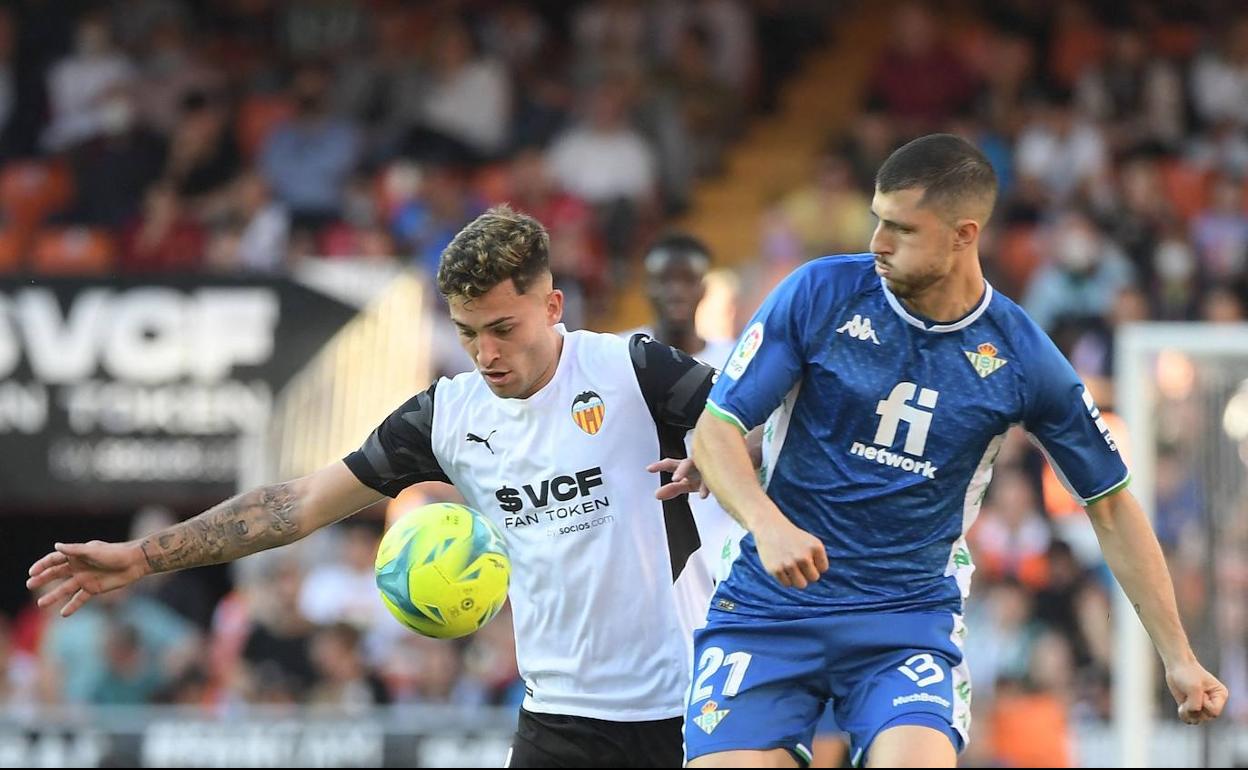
{"left": 685, "top": 612, "right": 971, "bottom": 765}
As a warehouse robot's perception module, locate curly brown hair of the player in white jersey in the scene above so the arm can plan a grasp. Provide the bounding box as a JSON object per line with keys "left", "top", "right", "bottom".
{"left": 438, "top": 205, "right": 550, "bottom": 300}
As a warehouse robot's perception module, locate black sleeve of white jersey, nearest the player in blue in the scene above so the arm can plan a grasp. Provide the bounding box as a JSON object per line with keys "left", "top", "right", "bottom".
{"left": 629, "top": 334, "right": 719, "bottom": 431}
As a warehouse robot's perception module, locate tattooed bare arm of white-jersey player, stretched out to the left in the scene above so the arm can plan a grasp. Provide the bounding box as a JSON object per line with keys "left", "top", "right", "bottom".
{"left": 26, "top": 462, "right": 382, "bottom": 616}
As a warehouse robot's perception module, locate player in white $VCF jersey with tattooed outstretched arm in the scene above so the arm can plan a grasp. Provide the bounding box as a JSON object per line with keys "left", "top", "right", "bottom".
{"left": 27, "top": 207, "right": 715, "bottom": 768}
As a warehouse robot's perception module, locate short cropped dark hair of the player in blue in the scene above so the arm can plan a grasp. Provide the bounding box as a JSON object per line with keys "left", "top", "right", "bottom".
{"left": 875, "top": 134, "right": 997, "bottom": 218}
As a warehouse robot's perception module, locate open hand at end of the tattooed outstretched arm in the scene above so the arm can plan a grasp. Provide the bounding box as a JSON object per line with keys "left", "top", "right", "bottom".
{"left": 26, "top": 540, "right": 151, "bottom": 618}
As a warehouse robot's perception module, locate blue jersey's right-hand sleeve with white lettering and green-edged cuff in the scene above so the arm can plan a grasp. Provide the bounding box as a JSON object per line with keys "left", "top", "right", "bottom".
{"left": 1023, "top": 328, "right": 1129, "bottom": 505}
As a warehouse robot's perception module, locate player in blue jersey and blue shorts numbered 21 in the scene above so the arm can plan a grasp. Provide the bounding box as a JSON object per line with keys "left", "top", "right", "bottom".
{"left": 685, "top": 135, "right": 1227, "bottom": 766}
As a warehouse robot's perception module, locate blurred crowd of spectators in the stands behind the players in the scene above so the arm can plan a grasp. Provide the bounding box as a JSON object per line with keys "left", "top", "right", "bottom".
{"left": 0, "top": 0, "right": 1248, "bottom": 766}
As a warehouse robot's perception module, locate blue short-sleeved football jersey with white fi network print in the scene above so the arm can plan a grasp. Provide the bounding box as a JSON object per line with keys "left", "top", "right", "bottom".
{"left": 706, "top": 255, "right": 1128, "bottom": 618}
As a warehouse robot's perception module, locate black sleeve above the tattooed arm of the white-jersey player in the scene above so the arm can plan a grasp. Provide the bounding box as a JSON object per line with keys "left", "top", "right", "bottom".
{"left": 342, "top": 383, "right": 451, "bottom": 497}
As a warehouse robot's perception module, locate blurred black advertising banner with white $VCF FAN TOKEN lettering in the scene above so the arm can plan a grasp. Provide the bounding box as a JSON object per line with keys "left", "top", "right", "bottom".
{"left": 0, "top": 276, "right": 356, "bottom": 510}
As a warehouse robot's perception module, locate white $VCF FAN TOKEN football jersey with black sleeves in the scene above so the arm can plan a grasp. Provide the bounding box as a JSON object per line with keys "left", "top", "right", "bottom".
{"left": 344, "top": 326, "right": 714, "bottom": 721}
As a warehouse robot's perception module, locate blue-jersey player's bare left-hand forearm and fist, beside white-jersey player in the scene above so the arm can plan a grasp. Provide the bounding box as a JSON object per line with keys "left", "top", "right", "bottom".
{"left": 694, "top": 411, "right": 827, "bottom": 588}
